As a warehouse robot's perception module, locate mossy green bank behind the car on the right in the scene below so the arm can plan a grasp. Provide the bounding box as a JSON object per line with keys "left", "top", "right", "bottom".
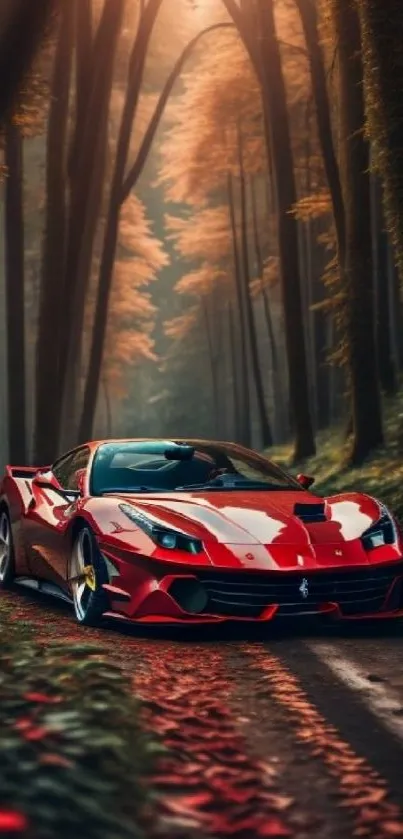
{"left": 269, "top": 393, "right": 403, "bottom": 519}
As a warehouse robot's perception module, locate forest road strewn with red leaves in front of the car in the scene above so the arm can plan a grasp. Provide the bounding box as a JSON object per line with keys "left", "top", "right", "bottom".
{"left": 1, "top": 592, "right": 403, "bottom": 839}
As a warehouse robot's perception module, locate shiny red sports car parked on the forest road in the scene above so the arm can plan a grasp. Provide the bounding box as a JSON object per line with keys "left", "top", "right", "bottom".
{"left": 0, "top": 439, "right": 403, "bottom": 624}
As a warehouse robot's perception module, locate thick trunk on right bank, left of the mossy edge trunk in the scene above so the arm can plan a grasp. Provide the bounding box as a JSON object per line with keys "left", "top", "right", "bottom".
{"left": 333, "top": 0, "right": 383, "bottom": 465}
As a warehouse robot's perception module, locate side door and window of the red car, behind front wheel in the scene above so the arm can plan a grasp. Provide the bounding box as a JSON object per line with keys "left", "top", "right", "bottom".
{"left": 27, "top": 446, "right": 90, "bottom": 584}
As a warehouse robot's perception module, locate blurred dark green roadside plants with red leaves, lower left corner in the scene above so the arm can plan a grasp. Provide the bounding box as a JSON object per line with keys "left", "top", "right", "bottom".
{"left": 0, "top": 598, "right": 153, "bottom": 839}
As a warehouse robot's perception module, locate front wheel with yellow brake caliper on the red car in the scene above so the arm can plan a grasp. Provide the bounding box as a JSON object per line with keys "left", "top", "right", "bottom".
{"left": 68, "top": 527, "right": 109, "bottom": 626}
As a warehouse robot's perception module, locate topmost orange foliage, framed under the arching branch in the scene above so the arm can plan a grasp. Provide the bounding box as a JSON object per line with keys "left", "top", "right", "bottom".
{"left": 160, "top": 30, "right": 266, "bottom": 205}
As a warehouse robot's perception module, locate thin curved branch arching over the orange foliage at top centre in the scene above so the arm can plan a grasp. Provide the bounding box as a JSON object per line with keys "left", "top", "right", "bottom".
{"left": 120, "top": 23, "right": 233, "bottom": 204}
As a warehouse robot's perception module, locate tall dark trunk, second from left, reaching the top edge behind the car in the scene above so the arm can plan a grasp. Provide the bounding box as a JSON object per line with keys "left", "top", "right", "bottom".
{"left": 34, "top": 3, "right": 74, "bottom": 463}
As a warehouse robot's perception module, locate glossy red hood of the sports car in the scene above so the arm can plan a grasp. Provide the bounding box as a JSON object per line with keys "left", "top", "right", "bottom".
{"left": 113, "top": 491, "right": 380, "bottom": 546}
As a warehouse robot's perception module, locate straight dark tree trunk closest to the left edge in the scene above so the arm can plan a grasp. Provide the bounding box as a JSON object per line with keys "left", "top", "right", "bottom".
{"left": 4, "top": 118, "right": 28, "bottom": 465}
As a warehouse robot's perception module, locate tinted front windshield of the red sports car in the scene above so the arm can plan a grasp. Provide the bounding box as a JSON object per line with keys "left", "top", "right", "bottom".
{"left": 91, "top": 440, "right": 301, "bottom": 495}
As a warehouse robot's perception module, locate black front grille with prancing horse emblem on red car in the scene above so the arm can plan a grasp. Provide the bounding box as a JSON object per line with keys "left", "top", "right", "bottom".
{"left": 197, "top": 562, "right": 403, "bottom": 617}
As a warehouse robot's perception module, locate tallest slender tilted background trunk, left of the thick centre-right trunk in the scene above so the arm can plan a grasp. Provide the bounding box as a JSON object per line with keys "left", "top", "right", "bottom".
{"left": 238, "top": 130, "right": 273, "bottom": 448}
